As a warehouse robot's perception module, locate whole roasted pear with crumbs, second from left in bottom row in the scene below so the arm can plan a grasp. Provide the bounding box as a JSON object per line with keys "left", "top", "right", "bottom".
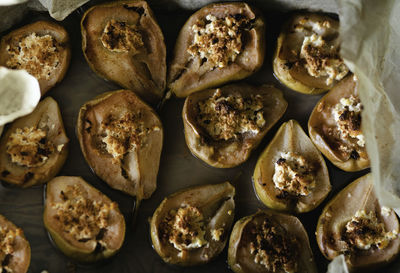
{"left": 43, "top": 176, "right": 125, "bottom": 263}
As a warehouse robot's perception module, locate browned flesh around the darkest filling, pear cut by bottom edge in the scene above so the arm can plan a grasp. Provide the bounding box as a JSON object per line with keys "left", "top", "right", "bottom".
{"left": 228, "top": 210, "right": 317, "bottom": 273}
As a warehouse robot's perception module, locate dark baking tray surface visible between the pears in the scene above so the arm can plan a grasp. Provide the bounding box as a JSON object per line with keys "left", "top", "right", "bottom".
{"left": 0, "top": 1, "right": 400, "bottom": 273}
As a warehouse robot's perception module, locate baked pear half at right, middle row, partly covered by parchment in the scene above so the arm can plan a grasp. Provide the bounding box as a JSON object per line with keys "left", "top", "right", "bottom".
{"left": 308, "top": 75, "right": 370, "bottom": 172}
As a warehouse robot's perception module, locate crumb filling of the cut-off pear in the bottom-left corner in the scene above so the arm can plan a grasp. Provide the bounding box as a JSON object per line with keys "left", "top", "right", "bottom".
{"left": 0, "top": 227, "right": 22, "bottom": 273}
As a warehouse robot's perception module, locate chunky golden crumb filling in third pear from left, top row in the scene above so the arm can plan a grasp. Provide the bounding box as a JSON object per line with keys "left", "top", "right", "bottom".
{"left": 187, "top": 14, "right": 250, "bottom": 70}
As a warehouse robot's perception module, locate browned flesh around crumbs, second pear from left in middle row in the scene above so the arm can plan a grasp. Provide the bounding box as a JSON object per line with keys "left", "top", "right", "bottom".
{"left": 77, "top": 90, "right": 163, "bottom": 200}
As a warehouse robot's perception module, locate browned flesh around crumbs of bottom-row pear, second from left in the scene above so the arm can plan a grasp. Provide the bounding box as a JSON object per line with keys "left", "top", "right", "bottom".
{"left": 43, "top": 176, "right": 125, "bottom": 263}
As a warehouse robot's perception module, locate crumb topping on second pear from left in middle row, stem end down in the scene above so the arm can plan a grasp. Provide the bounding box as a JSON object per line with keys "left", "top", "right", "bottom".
{"left": 100, "top": 112, "right": 150, "bottom": 163}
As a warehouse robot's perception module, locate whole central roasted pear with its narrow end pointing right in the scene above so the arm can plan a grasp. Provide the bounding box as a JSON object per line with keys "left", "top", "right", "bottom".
{"left": 182, "top": 83, "right": 287, "bottom": 168}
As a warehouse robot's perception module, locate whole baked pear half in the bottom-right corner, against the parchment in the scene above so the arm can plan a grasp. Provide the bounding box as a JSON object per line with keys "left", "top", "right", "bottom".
{"left": 316, "top": 174, "right": 400, "bottom": 270}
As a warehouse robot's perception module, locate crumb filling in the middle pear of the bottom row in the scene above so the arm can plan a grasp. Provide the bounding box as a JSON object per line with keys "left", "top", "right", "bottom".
{"left": 160, "top": 206, "right": 208, "bottom": 252}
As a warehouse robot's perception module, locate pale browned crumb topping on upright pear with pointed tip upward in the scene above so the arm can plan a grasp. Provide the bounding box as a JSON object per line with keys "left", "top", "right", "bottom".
{"left": 272, "top": 152, "right": 316, "bottom": 196}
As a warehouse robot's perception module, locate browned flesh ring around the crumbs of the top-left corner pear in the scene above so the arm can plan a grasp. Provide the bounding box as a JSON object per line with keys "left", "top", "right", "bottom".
{"left": 0, "top": 21, "right": 71, "bottom": 96}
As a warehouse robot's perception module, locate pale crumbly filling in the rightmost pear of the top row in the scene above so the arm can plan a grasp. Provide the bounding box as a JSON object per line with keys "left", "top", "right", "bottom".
{"left": 295, "top": 19, "right": 349, "bottom": 85}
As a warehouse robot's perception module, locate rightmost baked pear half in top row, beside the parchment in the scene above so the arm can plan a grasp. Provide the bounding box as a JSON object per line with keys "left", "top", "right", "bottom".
{"left": 273, "top": 13, "right": 349, "bottom": 94}
